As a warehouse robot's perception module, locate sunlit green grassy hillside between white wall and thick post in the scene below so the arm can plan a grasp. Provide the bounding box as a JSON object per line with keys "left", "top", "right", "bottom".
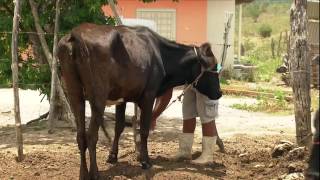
{"left": 234, "top": 1, "right": 290, "bottom": 81}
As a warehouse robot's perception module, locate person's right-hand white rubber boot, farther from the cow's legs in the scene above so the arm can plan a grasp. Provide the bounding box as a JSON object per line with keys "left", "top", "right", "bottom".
{"left": 191, "top": 136, "right": 217, "bottom": 165}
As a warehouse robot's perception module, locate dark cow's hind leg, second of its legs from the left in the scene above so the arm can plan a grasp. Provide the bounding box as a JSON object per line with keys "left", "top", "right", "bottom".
{"left": 87, "top": 99, "right": 104, "bottom": 179}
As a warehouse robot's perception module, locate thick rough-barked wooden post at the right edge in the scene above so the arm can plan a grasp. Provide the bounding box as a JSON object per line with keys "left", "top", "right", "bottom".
{"left": 289, "top": 0, "right": 312, "bottom": 146}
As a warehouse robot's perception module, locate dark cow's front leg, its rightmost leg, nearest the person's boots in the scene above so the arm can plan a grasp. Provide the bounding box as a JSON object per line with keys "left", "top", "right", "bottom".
{"left": 140, "top": 98, "right": 154, "bottom": 169}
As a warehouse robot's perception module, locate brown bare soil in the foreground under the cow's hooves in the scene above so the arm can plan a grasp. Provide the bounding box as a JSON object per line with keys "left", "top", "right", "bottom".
{"left": 0, "top": 118, "right": 308, "bottom": 179}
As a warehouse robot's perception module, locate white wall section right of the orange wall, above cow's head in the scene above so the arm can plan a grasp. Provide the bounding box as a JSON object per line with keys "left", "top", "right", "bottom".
{"left": 207, "top": 0, "right": 235, "bottom": 70}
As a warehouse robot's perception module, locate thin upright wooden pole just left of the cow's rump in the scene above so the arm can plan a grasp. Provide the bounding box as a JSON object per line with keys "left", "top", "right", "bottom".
{"left": 48, "top": 0, "right": 60, "bottom": 134}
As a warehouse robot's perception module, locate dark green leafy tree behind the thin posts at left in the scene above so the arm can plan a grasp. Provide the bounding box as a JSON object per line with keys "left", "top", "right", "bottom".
{"left": 0, "top": 0, "right": 177, "bottom": 126}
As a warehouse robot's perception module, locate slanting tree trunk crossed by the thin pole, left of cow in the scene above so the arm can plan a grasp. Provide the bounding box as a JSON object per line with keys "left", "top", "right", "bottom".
{"left": 29, "top": 0, "right": 75, "bottom": 127}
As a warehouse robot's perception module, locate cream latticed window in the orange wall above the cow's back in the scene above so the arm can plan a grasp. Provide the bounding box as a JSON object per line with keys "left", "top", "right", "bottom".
{"left": 137, "top": 9, "right": 176, "bottom": 40}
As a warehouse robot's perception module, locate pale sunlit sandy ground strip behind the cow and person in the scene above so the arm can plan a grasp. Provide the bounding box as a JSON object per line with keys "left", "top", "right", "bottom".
{"left": 0, "top": 89, "right": 295, "bottom": 137}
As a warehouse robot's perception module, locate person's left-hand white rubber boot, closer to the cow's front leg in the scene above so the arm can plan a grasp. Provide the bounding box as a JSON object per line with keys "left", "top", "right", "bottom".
{"left": 173, "top": 133, "right": 194, "bottom": 161}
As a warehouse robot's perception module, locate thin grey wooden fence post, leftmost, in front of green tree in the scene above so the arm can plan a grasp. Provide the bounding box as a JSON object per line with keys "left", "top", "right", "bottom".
{"left": 11, "top": 0, "right": 23, "bottom": 162}
